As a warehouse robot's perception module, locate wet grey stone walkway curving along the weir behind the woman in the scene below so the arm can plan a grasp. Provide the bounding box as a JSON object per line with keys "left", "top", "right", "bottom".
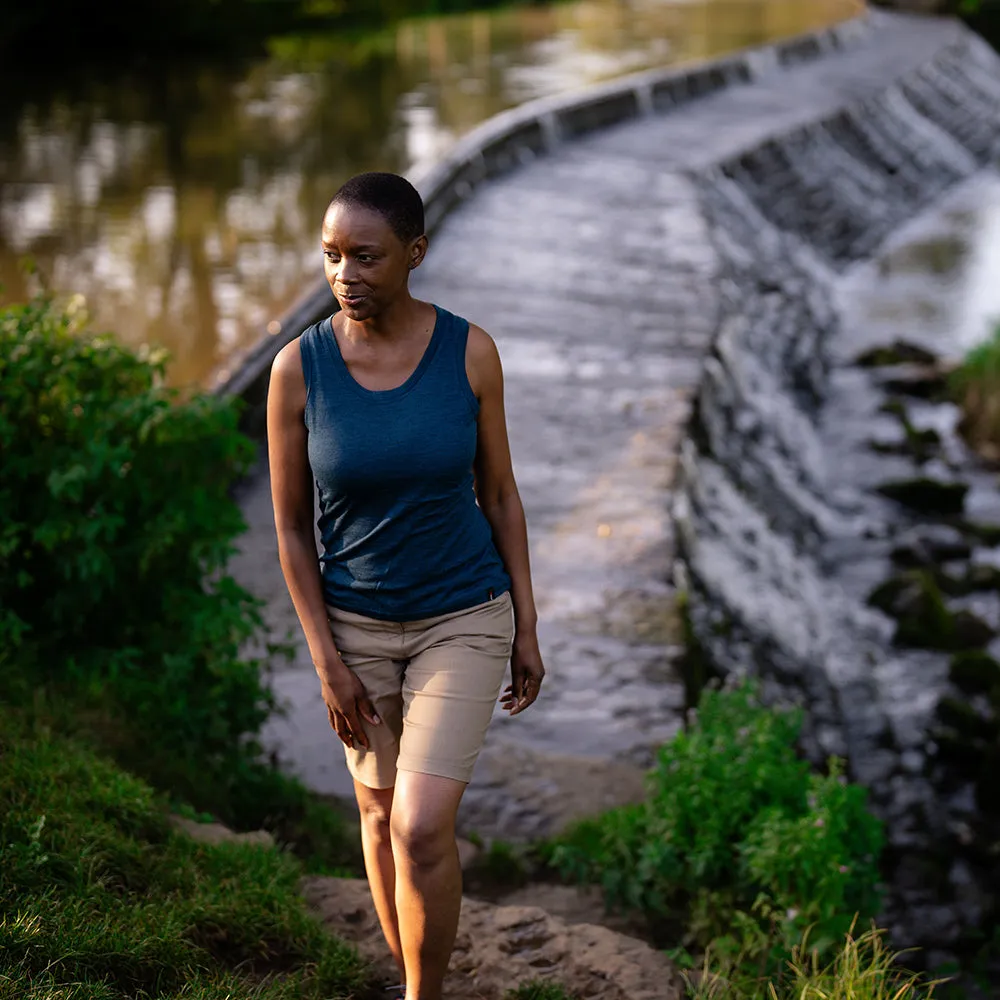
{"left": 234, "top": 16, "right": 964, "bottom": 839}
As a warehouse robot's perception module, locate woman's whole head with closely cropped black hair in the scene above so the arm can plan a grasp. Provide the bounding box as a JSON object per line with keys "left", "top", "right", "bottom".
{"left": 322, "top": 173, "right": 427, "bottom": 320}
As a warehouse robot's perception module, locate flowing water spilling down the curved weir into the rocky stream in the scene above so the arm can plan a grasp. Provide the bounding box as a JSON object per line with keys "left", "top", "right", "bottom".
{"left": 675, "top": 27, "right": 1000, "bottom": 944}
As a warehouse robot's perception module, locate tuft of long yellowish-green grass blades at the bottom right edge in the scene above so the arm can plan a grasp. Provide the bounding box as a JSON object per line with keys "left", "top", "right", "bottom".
{"left": 687, "top": 928, "right": 938, "bottom": 1000}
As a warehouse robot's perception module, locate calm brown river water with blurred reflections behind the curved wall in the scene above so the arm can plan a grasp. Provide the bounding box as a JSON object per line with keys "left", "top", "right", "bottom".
{"left": 0, "top": 0, "right": 857, "bottom": 384}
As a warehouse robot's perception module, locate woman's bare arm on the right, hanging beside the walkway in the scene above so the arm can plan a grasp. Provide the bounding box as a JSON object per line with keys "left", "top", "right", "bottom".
{"left": 466, "top": 326, "right": 545, "bottom": 715}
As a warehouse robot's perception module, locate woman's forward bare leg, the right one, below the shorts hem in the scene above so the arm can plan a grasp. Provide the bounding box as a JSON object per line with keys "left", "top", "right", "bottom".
{"left": 390, "top": 771, "right": 465, "bottom": 1000}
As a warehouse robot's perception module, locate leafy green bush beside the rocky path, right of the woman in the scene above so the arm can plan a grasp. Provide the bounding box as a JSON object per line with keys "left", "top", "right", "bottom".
{"left": 551, "top": 685, "right": 882, "bottom": 967}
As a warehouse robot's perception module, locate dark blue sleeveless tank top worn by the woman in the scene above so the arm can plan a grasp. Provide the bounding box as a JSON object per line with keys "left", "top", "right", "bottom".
{"left": 300, "top": 306, "right": 510, "bottom": 621}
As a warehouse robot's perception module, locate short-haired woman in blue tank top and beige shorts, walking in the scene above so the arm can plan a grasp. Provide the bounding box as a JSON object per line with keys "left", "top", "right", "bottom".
{"left": 267, "top": 173, "right": 545, "bottom": 1000}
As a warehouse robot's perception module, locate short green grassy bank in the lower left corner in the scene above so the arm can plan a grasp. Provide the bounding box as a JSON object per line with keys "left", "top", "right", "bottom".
{"left": 0, "top": 717, "right": 364, "bottom": 1000}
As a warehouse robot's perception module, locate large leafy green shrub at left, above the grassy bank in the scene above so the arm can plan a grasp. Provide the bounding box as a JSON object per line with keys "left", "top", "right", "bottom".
{"left": 0, "top": 297, "right": 272, "bottom": 820}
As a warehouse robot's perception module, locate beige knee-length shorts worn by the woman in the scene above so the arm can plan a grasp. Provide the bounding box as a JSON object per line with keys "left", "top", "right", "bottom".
{"left": 327, "top": 593, "right": 514, "bottom": 788}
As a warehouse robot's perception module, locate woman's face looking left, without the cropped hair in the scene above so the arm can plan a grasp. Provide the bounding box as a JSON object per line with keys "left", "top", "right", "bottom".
{"left": 322, "top": 204, "right": 426, "bottom": 321}
